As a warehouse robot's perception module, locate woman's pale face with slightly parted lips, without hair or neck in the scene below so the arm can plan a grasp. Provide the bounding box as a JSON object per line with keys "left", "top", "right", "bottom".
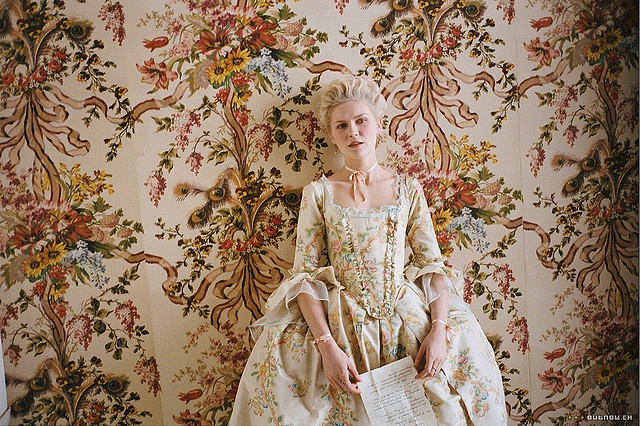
{"left": 329, "top": 101, "right": 381, "bottom": 159}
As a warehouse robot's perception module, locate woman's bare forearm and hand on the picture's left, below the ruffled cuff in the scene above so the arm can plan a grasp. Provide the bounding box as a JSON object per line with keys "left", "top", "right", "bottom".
{"left": 297, "top": 293, "right": 362, "bottom": 393}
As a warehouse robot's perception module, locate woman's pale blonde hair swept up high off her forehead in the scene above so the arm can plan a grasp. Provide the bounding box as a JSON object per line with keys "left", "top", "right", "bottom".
{"left": 318, "top": 75, "right": 387, "bottom": 132}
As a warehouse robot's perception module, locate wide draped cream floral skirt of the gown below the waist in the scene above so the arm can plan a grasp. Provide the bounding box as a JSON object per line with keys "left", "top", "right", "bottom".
{"left": 230, "top": 283, "right": 506, "bottom": 426}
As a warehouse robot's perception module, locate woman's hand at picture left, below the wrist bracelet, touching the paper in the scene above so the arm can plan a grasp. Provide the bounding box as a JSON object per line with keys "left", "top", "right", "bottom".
{"left": 317, "top": 338, "right": 362, "bottom": 394}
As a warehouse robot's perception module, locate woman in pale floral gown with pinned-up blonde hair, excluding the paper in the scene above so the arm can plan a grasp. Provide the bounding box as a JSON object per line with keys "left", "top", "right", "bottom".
{"left": 230, "top": 77, "right": 506, "bottom": 426}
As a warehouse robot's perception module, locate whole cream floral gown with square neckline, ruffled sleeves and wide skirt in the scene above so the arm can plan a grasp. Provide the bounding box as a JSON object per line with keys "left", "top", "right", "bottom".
{"left": 230, "top": 176, "right": 506, "bottom": 426}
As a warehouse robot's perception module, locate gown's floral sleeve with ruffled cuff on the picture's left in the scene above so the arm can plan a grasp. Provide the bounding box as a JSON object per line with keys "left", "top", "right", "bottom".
{"left": 252, "top": 181, "right": 339, "bottom": 338}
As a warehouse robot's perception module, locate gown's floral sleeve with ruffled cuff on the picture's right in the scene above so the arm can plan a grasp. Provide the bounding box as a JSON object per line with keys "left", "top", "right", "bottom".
{"left": 405, "top": 179, "right": 463, "bottom": 305}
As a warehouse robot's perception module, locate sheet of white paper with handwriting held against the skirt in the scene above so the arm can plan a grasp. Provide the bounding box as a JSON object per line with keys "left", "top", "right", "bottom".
{"left": 358, "top": 357, "right": 437, "bottom": 426}
